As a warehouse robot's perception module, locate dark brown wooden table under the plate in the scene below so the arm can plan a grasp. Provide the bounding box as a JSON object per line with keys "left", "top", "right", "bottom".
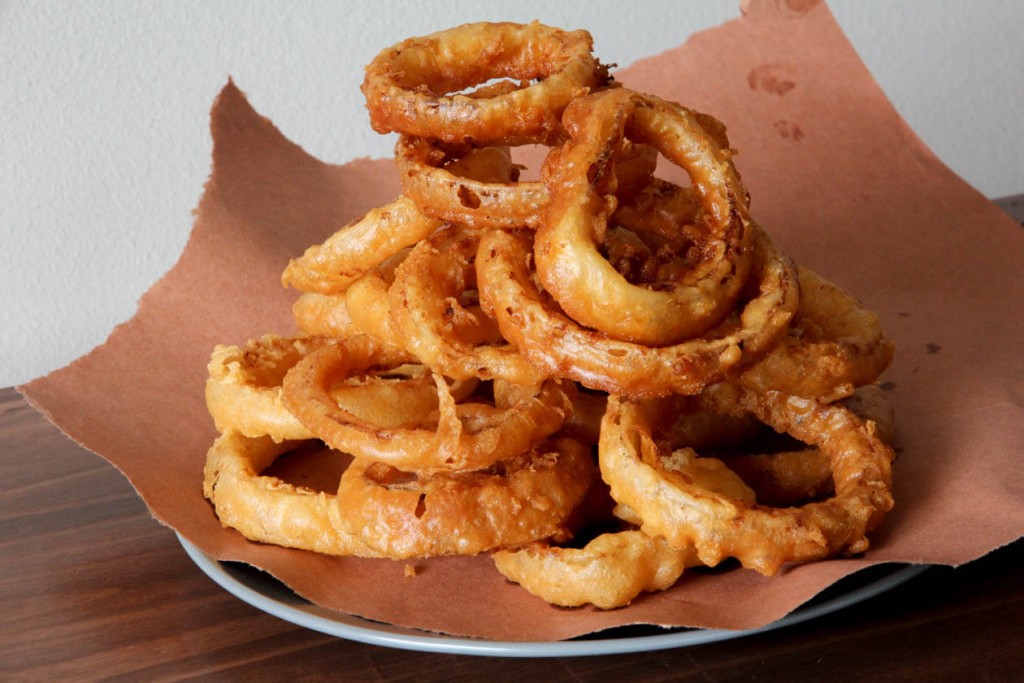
{"left": 0, "top": 196, "right": 1024, "bottom": 681}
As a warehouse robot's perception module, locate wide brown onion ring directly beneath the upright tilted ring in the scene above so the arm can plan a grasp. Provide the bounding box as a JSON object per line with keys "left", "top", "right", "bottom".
{"left": 476, "top": 223, "right": 800, "bottom": 396}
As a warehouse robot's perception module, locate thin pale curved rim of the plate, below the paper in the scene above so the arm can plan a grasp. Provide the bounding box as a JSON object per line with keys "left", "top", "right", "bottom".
{"left": 175, "top": 533, "right": 931, "bottom": 657}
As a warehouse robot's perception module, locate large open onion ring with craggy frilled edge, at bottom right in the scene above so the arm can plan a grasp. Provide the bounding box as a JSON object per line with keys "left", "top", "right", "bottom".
{"left": 599, "top": 384, "right": 893, "bottom": 574}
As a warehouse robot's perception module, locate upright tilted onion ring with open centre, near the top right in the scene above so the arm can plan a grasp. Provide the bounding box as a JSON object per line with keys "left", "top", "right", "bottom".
{"left": 534, "top": 88, "right": 751, "bottom": 346}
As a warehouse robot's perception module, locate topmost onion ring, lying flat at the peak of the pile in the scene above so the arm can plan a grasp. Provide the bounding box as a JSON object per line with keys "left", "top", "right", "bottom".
{"left": 362, "top": 22, "right": 608, "bottom": 145}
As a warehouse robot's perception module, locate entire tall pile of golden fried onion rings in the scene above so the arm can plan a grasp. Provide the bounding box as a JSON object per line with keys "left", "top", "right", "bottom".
{"left": 204, "top": 23, "right": 893, "bottom": 607}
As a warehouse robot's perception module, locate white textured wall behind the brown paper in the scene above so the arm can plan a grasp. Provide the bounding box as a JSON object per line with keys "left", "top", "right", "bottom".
{"left": 0, "top": 0, "right": 1024, "bottom": 386}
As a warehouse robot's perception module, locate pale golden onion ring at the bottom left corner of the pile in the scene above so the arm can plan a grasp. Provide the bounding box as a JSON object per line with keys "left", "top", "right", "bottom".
{"left": 203, "top": 430, "right": 381, "bottom": 557}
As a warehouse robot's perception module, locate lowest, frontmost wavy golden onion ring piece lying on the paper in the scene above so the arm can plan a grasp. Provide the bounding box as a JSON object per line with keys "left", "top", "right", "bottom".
{"left": 494, "top": 529, "right": 699, "bottom": 609}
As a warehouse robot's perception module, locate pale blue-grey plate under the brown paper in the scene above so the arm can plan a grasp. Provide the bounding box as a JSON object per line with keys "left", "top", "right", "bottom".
{"left": 178, "top": 536, "right": 928, "bottom": 657}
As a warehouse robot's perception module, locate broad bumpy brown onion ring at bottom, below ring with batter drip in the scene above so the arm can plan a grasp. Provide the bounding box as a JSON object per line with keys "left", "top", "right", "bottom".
{"left": 338, "top": 438, "right": 594, "bottom": 559}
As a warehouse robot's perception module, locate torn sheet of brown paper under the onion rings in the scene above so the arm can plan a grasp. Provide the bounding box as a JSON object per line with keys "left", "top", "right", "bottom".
{"left": 19, "top": 0, "right": 1024, "bottom": 641}
